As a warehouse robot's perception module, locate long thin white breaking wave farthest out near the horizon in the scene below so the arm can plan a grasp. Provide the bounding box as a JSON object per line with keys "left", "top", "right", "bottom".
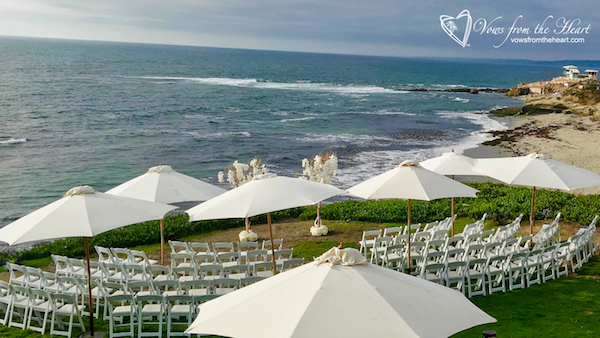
{"left": 141, "top": 76, "right": 407, "bottom": 95}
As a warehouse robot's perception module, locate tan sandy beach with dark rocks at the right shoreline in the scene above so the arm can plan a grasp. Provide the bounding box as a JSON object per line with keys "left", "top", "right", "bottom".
{"left": 483, "top": 113, "right": 600, "bottom": 194}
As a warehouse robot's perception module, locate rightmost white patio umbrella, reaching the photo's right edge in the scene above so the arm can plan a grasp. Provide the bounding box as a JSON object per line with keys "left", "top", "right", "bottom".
{"left": 473, "top": 153, "right": 600, "bottom": 235}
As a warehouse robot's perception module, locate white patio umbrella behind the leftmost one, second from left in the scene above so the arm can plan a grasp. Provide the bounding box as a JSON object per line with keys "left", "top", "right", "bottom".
{"left": 106, "top": 164, "right": 226, "bottom": 264}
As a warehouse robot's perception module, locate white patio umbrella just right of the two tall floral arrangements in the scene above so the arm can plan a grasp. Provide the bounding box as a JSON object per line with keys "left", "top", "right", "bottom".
{"left": 347, "top": 160, "right": 478, "bottom": 268}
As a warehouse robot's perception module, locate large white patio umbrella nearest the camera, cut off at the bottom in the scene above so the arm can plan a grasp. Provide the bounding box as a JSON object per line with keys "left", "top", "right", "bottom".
{"left": 186, "top": 248, "right": 496, "bottom": 338}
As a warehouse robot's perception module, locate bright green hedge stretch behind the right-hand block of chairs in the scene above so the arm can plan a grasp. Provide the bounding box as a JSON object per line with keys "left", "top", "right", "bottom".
{"left": 300, "top": 182, "right": 600, "bottom": 224}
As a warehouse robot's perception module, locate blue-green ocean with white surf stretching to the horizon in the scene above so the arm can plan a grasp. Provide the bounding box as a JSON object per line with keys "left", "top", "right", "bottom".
{"left": 0, "top": 37, "right": 599, "bottom": 226}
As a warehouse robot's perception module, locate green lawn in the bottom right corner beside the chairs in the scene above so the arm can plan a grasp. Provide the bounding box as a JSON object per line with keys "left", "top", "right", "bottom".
{"left": 452, "top": 256, "right": 600, "bottom": 338}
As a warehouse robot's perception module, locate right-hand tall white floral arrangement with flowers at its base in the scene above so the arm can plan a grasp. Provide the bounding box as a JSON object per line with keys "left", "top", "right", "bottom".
{"left": 300, "top": 153, "right": 338, "bottom": 237}
